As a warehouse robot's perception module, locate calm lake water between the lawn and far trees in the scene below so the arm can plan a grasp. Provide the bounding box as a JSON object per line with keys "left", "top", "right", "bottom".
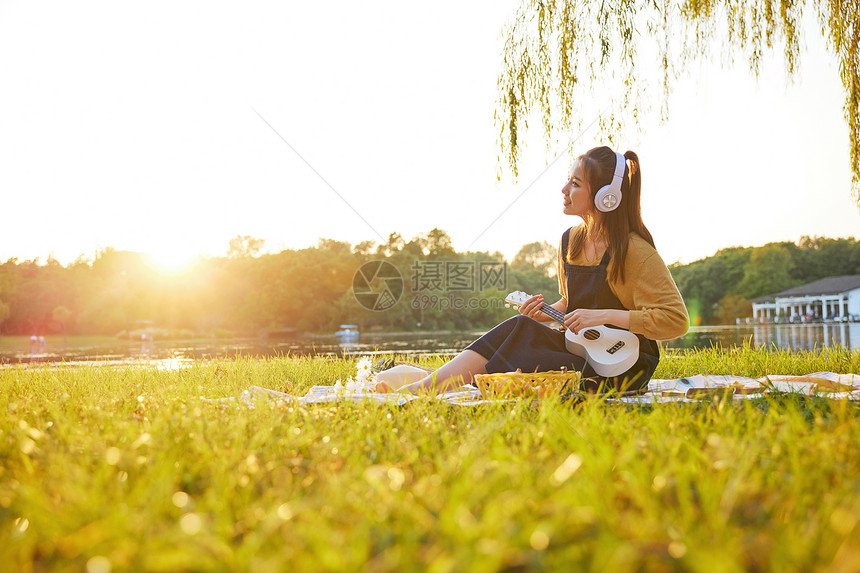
{"left": 0, "top": 323, "right": 860, "bottom": 367}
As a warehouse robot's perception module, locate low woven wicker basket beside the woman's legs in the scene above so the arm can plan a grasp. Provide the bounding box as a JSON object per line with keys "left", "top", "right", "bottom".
{"left": 475, "top": 369, "right": 580, "bottom": 400}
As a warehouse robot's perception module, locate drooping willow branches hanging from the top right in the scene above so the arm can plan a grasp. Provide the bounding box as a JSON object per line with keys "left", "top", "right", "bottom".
{"left": 496, "top": 0, "right": 860, "bottom": 205}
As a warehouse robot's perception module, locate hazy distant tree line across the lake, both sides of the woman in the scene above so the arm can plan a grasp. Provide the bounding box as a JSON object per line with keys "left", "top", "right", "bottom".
{"left": 0, "top": 229, "right": 860, "bottom": 336}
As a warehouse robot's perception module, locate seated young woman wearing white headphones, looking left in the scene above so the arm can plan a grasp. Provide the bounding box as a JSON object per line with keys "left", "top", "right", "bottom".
{"left": 376, "top": 147, "right": 689, "bottom": 393}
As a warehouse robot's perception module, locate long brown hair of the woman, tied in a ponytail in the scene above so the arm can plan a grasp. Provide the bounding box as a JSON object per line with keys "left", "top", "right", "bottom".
{"left": 567, "top": 146, "right": 654, "bottom": 282}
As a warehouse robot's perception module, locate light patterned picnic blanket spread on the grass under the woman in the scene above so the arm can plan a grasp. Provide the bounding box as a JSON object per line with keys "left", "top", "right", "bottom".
{"left": 207, "top": 372, "right": 860, "bottom": 408}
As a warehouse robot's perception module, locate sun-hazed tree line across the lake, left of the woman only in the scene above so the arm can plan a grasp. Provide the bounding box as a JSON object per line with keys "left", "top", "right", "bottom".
{"left": 0, "top": 229, "right": 558, "bottom": 336}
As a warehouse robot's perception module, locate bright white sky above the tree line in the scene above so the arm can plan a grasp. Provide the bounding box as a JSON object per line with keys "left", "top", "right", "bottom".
{"left": 0, "top": 0, "right": 860, "bottom": 270}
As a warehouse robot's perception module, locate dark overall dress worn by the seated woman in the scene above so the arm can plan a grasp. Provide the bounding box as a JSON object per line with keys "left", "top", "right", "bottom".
{"left": 467, "top": 229, "right": 660, "bottom": 392}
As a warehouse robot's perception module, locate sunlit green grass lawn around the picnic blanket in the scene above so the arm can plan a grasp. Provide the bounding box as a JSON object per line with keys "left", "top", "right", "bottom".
{"left": 0, "top": 348, "right": 860, "bottom": 571}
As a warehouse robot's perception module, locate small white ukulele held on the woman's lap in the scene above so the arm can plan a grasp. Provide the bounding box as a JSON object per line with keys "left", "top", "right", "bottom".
{"left": 505, "top": 291, "right": 639, "bottom": 377}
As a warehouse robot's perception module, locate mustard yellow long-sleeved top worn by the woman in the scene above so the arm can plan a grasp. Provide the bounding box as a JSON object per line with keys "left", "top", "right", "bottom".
{"left": 558, "top": 230, "right": 690, "bottom": 340}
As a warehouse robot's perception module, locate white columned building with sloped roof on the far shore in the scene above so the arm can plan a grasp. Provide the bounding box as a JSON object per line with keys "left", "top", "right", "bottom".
{"left": 752, "top": 275, "right": 860, "bottom": 322}
